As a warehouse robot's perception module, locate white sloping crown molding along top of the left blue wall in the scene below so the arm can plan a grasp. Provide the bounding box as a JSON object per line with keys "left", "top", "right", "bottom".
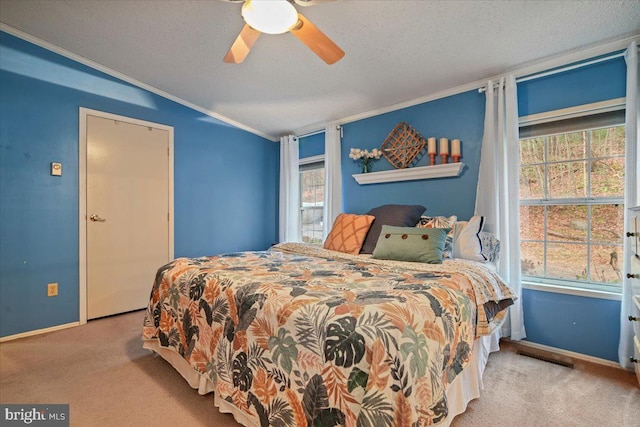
{"left": 0, "top": 22, "right": 278, "bottom": 142}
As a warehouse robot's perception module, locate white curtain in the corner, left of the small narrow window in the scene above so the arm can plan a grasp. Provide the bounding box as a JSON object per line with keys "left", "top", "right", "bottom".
{"left": 279, "top": 135, "right": 300, "bottom": 242}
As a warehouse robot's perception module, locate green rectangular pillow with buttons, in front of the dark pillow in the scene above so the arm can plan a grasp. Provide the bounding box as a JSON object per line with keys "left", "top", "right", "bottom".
{"left": 373, "top": 225, "right": 451, "bottom": 264}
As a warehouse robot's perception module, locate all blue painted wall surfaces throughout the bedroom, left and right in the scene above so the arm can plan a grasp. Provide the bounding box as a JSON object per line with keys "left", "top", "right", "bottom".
{"left": 0, "top": 28, "right": 626, "bottom": 360}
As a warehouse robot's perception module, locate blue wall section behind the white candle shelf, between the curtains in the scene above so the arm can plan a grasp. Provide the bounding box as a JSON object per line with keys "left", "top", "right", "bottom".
{"left": 342, "top": 90, "right": 485, "bottom": 220}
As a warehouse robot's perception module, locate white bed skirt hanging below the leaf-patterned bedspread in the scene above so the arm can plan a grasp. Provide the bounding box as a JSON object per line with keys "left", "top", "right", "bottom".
{"left": 143, "top": 333, "right": 500, "bottom": 427}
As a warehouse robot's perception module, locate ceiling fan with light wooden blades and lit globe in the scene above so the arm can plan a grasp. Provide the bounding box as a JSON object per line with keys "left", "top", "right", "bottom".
{"left": 224, "top": 0, "right": 344, "bottom": 64}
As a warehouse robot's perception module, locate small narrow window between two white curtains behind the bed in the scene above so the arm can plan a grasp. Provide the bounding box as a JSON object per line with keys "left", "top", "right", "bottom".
{"left": 300, "top": 158, "right": 324, "bottom": 244}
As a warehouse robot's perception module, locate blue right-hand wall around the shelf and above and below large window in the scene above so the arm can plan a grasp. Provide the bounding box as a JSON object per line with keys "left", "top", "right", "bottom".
{"left": 342, "top": 58, "right": 626, "bottom": 360}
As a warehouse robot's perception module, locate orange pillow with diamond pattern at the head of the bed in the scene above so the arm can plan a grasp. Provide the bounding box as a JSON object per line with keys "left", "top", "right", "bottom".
{"left": 324, "top": 214, "right": 376, "bottom": 255}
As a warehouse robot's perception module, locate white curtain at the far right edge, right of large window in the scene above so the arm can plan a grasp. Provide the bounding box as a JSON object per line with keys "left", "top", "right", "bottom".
{"left": 618, "top": 41, "right": 640, "bottom": 368}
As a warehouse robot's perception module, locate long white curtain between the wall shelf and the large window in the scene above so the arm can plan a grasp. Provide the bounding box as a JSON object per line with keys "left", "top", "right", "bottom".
{"left": 475, "top": 75, "right": 526, "bottom": 340}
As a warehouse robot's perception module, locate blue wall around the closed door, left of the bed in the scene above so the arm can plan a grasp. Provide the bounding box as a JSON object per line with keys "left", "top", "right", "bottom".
{"left": 0, "top": 32, "right": 279, "bottom": 336}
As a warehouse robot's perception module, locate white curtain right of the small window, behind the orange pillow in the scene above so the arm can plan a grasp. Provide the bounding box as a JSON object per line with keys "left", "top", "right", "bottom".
{"left": 322, "top": 123, "right": 342, "bottom": 240}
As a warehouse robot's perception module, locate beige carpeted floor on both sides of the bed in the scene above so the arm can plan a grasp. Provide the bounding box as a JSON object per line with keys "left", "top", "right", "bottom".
{"left": 0, "top": 311, "right": 640, "bottom": 427}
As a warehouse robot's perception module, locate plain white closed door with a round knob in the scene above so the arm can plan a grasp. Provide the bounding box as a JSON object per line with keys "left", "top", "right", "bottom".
{"left": 86, "top": 115, "right": 172, "bottom": 319}
